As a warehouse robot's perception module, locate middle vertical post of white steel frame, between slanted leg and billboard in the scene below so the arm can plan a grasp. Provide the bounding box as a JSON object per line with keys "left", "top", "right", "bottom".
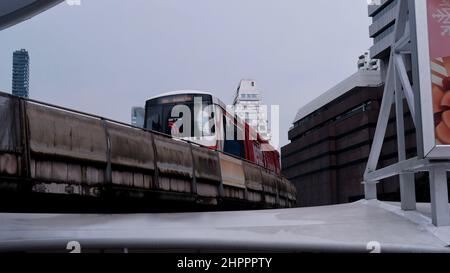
{"left": 394, "top": 67, "right": 416, "bottom": 210}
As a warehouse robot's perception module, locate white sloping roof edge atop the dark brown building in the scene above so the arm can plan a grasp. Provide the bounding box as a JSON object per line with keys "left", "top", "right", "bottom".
{"left": 293, "top": 70, "right": 383, "bottom": 123}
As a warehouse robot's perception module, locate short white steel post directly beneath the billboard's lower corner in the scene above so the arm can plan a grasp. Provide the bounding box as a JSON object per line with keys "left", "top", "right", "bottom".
{"left": 430, "top": 167, "right": 450, "bottom": 227}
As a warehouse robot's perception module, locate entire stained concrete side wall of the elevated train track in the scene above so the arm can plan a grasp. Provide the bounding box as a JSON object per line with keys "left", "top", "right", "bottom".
{"left": 0, "top": 93, "right": 296, "bottom": 207}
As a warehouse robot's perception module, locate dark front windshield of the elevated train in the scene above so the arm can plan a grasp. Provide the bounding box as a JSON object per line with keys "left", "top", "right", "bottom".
{"left": 145, "top": 94, "right": 215, "bottom": 137}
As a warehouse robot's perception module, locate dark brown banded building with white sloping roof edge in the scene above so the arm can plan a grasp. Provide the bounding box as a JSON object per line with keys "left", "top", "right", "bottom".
{"left": 281, "top": 66, "right": 382, "bottom": 206}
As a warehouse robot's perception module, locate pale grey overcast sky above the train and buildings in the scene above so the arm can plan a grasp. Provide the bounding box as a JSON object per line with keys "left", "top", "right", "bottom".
{"left": 0, "top": 0, "right": 371, "bottom": 145}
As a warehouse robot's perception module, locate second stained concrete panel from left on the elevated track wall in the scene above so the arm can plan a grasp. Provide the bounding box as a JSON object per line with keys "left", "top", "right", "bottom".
{"left": 25, "top": 102, "right": 107, "bottom": 189}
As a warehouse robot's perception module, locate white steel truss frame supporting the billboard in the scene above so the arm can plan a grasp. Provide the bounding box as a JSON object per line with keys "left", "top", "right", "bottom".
{"left": 363, "top": 0, "right": 450, "bottom": 226}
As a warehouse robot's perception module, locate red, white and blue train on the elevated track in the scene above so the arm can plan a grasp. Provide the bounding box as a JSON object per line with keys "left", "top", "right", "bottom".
{"left": 144, "top": 90, "right": 281, "bottom": 175}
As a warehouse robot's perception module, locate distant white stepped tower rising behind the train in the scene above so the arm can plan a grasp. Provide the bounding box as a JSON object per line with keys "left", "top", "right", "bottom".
{"left": 233, "top": 80, "right": 271, "bottom": 141}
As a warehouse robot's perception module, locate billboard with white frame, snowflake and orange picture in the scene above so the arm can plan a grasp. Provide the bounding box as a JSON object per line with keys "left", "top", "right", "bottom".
{"left": 414, "top": 0, "right": 450, "bottom": 159}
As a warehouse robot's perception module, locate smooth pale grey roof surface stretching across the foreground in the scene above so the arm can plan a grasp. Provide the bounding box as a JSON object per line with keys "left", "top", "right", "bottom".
{"left": 0, "top": 201, "right": 450, "bottom": 252}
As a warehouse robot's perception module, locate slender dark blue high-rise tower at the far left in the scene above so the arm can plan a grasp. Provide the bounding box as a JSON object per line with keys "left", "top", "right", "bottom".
{"left": 12, "top": 49, "right": 30, "bottom": 98}
